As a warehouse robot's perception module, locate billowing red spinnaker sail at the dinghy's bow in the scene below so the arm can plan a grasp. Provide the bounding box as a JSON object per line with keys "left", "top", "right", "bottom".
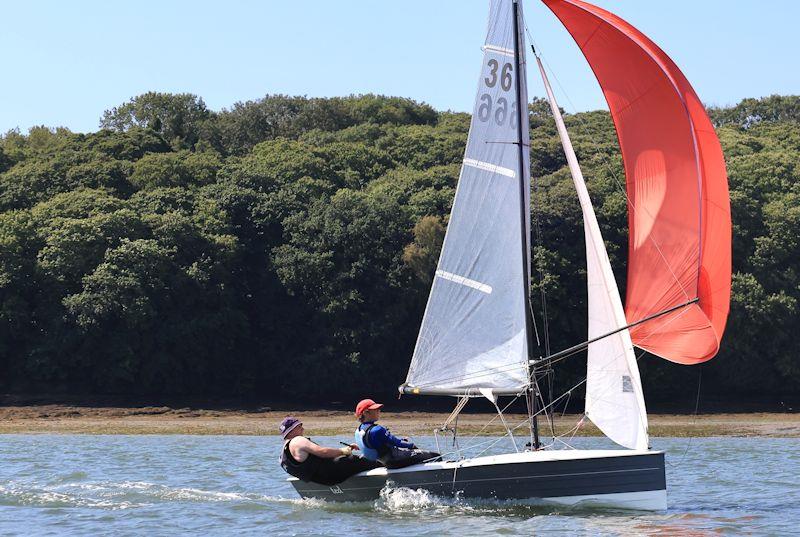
{"left": 542, "top": 0, "right": 731, "bottom": 364}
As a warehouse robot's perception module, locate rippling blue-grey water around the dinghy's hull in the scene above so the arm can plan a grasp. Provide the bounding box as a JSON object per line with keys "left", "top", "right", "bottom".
{"left": 0, "top": 435, "right": 800, "bottom": 537}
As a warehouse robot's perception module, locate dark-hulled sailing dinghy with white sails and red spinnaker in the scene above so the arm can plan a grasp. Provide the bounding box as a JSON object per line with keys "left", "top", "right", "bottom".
{"left": 290, "top": 0, "right": 731, "bottom": 510}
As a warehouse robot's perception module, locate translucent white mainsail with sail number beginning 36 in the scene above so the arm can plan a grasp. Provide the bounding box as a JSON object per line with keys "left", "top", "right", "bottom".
{"left": 405, "top": 0, "right": 530, "bottom": 395}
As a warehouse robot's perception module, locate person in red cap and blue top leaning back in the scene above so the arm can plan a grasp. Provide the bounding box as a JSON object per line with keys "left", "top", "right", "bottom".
{"left": 355, "top": 399, "right": 440, "bottom": 468}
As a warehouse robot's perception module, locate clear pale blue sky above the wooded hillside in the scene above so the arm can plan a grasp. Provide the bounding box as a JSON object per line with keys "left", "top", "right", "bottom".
{"left": 0, "top": 0, "right": 800, "bottom": 133}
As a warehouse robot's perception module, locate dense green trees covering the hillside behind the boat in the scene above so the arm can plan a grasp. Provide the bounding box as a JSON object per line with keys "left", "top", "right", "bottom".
{"left": 0, "top": 93, "right": 800, "bottom": 400}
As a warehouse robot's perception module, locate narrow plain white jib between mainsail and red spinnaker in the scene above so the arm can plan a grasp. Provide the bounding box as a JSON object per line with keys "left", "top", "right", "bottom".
{"left": 536, "top": 57, "right": 648, "bottom": 449}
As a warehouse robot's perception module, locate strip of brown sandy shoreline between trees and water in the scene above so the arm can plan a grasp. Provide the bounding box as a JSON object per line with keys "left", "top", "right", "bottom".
{"left": 0, "top": 405, "right": 800, "bottom": 438}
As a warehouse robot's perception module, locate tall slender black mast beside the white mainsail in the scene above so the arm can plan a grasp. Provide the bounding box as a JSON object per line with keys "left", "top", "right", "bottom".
{"left": 513, "top": 0, "right": 541, "bottom": 449}
